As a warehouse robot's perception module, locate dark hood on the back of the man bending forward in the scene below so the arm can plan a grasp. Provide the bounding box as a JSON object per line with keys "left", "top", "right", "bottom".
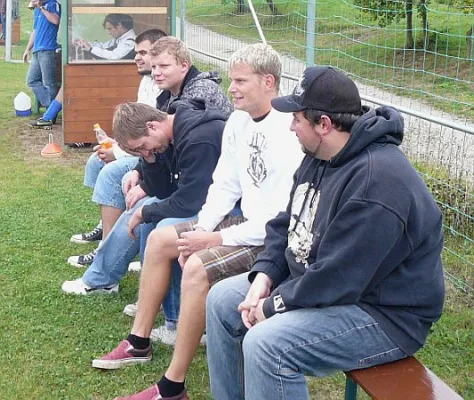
{"left": 168, "top": 99, "right": 226, "bottom": 146}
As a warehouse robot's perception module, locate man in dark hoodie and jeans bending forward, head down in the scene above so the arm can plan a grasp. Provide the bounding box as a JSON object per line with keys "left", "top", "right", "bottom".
{"left": 62, "top": 100, "right": 225, "bottom": 295}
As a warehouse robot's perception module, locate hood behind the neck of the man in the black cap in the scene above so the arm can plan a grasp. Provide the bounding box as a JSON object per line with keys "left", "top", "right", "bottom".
{"left": 330, "top": 106, "right": 404, "bottom": 167}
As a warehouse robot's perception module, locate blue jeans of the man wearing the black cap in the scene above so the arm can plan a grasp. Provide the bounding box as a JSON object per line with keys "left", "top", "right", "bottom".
{"left": 206, "top": 274, "right": 407, "bottom": 400}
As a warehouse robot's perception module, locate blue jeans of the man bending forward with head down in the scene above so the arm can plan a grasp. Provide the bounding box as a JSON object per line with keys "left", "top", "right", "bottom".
{"left": 82, "top": 197, "right": 196, "bottom": 323}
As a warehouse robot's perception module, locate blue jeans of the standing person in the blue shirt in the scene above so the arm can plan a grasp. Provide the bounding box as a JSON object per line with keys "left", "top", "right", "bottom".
{"left": 26, "top": 50, "right": 58, "bottom": 107}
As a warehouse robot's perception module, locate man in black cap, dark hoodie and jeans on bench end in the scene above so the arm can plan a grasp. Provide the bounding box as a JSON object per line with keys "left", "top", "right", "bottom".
{"left": 206, "top": 66, "right": 444, "bottom": 400}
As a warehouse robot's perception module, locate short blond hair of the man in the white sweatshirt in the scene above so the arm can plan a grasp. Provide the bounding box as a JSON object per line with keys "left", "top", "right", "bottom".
{"left": 229, "top": 43, "right": 282, "bottom": 91}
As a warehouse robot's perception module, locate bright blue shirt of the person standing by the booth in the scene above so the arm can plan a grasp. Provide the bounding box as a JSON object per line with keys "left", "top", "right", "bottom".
{"left": 33, "top": 0, "right": 61, "bottom": 53}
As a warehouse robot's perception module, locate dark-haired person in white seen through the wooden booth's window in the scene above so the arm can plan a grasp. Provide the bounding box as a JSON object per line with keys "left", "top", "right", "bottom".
{"left": 73, "top": 14, "right": 137, "bottom": 60}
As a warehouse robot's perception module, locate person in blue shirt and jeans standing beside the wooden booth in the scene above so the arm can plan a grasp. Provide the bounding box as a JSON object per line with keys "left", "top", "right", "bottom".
{"left": 23, "top": 0, "right": 61, "bottom": 107}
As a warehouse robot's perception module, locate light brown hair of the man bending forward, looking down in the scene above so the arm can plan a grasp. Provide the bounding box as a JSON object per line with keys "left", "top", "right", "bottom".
{"left": 112, "top": 103, "right": 167, "bottom": 149}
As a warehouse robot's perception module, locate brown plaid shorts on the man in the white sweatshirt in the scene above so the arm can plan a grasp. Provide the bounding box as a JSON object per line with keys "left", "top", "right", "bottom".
{"left": 174, "top": 216, "right": 264, "bottom": 286}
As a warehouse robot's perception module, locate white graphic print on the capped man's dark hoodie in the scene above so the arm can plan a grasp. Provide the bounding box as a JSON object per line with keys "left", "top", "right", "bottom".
{"left": 288, "top": 182, "right": 321, "bottom": 268}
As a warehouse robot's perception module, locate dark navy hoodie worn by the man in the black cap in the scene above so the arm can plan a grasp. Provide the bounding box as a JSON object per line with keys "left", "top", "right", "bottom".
{"left": 249, "top": 107, "right": 444, "bottom": 354}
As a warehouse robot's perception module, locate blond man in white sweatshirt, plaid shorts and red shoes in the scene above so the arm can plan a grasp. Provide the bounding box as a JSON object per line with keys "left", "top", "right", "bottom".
{"left": 92, "top": 44, "right": 303, "bottom": 400}
